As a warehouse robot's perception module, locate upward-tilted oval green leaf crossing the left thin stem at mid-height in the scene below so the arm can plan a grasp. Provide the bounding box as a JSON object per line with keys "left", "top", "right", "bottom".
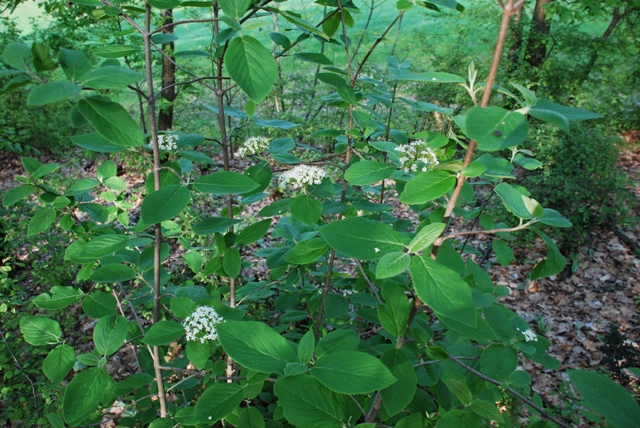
{"left": 140, "top": 184, "right": 191, "bottom": 225}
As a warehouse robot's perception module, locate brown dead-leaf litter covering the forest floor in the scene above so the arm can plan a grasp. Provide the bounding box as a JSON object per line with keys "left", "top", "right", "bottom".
{"left": 0, "top": 140, "right": 640, "bottom": 422}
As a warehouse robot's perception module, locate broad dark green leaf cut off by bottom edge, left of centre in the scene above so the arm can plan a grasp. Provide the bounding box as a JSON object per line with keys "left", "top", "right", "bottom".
{"left": 274, "top": 375, "right": 348, "bottom": 428}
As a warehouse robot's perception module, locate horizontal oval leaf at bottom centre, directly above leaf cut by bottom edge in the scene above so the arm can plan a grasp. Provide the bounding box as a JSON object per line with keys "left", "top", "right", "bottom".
{"left": 309, "top": 351, "right": 396, "bottom": 394}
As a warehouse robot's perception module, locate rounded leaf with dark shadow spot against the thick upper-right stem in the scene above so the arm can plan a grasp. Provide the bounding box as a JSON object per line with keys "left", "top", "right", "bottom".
{"left": 463, "top": 106, "right": 529, "bottom": 151}
